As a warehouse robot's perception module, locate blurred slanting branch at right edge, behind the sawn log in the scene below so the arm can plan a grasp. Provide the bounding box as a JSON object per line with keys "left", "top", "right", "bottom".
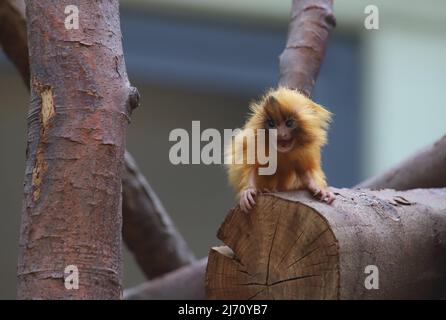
{"left": 357, "top": 136, "right": 446, "bottom": 190}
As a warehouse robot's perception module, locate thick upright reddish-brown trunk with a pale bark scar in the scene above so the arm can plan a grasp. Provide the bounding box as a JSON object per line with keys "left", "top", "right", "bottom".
{"left": 18, "top": 0, "right": 134, "bottom": 299}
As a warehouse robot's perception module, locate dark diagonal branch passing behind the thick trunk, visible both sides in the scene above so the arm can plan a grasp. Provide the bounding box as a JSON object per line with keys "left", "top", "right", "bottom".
{"left": 0, "top": 0, "right": 194, "bottom": 279}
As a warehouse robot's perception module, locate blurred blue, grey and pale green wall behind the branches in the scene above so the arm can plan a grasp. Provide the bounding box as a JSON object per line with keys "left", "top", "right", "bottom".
{"left": 0, "top": 0, "right": 446, "bottom": 298}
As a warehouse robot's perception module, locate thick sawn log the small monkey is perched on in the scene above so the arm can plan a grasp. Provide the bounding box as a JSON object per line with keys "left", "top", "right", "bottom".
{"left": 206, "top": 188, "right": 446, "bottom": 299}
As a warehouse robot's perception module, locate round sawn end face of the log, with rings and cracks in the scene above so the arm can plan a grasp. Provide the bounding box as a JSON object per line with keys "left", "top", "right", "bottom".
{"left": 207, "top": 196, "right": 339, "bottom": 299}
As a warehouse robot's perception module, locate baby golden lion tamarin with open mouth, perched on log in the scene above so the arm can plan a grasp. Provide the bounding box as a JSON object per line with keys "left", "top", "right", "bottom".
{"left": 225, "top": 87, "right": 335, "bottom": 212}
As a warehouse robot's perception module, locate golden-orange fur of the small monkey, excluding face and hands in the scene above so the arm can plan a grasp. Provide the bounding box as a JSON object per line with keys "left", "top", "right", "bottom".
{"left": 225, "top": 87, "right": 331, "bottom": 196}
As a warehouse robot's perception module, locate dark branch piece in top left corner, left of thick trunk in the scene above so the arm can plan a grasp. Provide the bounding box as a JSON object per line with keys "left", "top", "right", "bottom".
{"left": 0, "top": 0, "right": 29, "bottom": 88}
